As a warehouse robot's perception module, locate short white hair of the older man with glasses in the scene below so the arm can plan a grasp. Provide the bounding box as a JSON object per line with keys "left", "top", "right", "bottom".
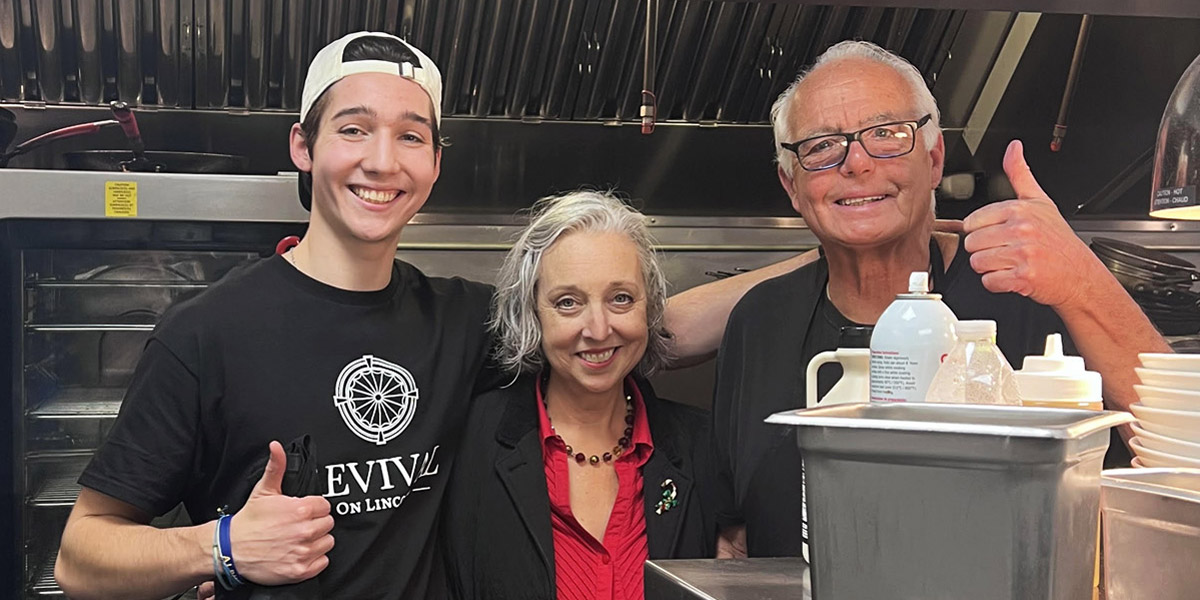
{"left": 770, "top": 40, "right": 942, "bottom": 176}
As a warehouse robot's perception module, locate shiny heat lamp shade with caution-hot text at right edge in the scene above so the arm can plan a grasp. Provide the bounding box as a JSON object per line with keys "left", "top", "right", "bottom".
{"left": 1150, "top": 51, "right": 1200, "bottom": 221}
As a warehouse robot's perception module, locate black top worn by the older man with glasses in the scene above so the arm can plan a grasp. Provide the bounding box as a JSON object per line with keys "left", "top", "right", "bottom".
{"left": 713, "top": 240, "right": 1073, "bottom": 557}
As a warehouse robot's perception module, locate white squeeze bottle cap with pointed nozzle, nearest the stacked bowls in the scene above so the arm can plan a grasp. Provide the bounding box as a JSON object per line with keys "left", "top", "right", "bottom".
{"left": 1015, "top": 334, "right": 1102, "bottom": 402}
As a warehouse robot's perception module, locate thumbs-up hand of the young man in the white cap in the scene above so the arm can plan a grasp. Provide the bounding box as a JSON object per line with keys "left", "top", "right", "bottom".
{"left": 229, "top": 442, "right": 334, "bottom": 586}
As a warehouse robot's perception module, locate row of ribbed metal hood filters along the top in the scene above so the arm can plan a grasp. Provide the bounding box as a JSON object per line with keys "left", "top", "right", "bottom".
{"left": 0, "top": 0, "right": 964, "bottom": 124}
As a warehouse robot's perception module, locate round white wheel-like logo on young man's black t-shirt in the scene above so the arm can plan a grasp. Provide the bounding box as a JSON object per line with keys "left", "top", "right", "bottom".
{"left": 334, "top": 354, "right": 420, "bottom": 446}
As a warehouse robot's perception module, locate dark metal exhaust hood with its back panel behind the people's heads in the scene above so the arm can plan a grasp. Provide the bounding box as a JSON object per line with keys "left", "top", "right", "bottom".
{"left": 0, "top": 0, "right": 1200, "bottom": 217}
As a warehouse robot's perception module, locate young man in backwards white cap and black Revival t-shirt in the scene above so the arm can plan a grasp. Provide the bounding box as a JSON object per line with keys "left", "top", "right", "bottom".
{"left": 56, "top": 32, "right": 491, "bottom": 599}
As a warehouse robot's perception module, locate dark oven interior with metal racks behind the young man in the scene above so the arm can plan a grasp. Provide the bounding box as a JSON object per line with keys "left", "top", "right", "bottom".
{"left": 8, "top": 226, "right": 277, "bottom": 600}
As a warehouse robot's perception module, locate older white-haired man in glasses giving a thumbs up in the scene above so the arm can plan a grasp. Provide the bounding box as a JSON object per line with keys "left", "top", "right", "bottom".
{"left": 713, "top": 42, "right": 1166, "bottom": 557}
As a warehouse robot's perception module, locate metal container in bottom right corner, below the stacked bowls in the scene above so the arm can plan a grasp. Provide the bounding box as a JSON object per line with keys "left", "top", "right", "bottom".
{"left": 1100, "top": 468, "right": 1200, "bottom": 600}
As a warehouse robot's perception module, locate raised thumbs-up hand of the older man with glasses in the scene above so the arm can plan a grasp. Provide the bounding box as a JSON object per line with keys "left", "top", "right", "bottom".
{"left": 962, "top": 140, "right": 1109, "bottom": 308}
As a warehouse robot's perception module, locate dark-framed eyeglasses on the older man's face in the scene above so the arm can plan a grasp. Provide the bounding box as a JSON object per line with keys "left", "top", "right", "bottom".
{"left": 780, "top": 114, "right": 934, "bottom": 170}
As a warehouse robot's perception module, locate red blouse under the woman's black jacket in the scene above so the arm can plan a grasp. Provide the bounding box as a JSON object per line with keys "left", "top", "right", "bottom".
{"left": 538, "top": 378, "right": 654, "bottom": 600}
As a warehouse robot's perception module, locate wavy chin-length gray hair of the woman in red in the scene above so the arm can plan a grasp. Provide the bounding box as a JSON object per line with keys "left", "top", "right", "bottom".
{"left": 488, "top": 191, "right": 670, "bottom": 376}
